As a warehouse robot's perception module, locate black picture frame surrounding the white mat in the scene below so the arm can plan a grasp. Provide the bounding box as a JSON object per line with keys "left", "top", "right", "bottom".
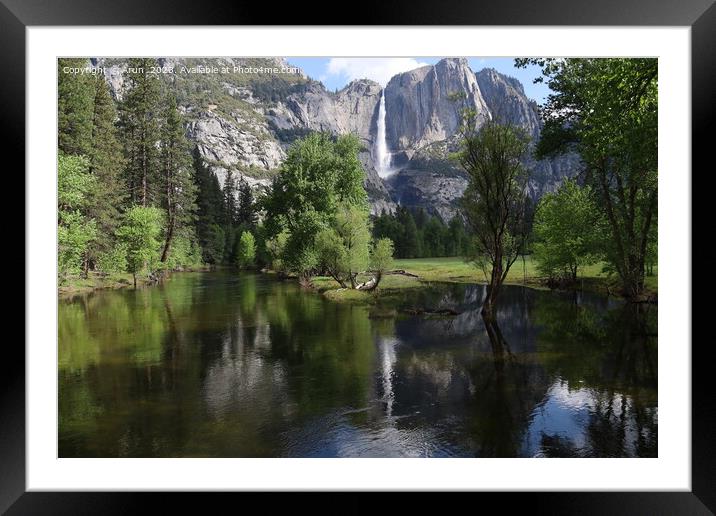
{"left": 0, "top": 0, "right": 716, "bottom": 514}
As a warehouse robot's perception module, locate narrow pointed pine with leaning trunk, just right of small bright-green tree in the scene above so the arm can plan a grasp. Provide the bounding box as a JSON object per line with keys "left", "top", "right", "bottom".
{"left": 159, "top": 90, "right": 197, "bottom": 263}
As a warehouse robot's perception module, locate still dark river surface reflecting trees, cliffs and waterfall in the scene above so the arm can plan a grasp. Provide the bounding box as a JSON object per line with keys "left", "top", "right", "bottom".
{"left": 59, "top": 272, "right": 658, "bottom": 457}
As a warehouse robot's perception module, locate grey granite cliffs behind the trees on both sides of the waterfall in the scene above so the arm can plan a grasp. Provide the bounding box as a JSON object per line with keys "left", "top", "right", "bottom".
{"left": 93, "top": 58, "right": 579, "bottom": 221}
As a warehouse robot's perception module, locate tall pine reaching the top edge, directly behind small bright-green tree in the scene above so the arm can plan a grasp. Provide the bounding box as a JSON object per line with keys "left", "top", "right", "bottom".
{"left": 120, "top": 59, "right": 161, "bottom": 206}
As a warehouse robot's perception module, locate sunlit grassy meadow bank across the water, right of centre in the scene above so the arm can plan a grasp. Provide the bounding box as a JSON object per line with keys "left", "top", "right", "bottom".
{"left": 313, "top": 257, "right": 658, "bottom": 302}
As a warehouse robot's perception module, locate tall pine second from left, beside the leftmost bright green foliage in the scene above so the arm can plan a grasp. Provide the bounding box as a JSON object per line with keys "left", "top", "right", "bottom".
{"left": 85, "top": 77, "right": 126, "bottom": 273}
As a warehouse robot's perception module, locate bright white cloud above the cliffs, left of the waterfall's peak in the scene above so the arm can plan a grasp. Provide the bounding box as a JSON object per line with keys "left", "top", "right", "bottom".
{"left": 326, "top": 57, "right": 427, "bottom": 86}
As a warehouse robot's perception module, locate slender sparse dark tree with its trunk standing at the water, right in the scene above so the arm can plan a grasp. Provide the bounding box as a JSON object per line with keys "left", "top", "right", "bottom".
{"left": 457, "top": 118, "right": 529, "bottom": 319}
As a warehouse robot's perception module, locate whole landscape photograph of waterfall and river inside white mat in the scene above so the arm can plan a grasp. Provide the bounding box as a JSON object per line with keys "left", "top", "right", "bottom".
{"left": 56, "top": 56, "right": 659, "bottom": 458}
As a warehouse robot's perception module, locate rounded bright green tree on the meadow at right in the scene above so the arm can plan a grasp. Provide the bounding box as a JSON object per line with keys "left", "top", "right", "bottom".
{"left": 534, "top": 180, "right": 601, "bottom": 282}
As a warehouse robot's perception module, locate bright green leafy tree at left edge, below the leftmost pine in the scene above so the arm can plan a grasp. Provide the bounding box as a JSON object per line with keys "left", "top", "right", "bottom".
{"left": 57, "top": 153, "right": 97, "bottom": 277}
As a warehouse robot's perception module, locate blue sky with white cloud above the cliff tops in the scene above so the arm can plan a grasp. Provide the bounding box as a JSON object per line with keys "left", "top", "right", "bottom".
{"left": 287, "top": 57, "right": 549, "bottom": 104}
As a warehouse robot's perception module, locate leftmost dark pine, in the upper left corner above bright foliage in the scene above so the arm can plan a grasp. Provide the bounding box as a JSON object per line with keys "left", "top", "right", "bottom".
{"left": 57, "top": 59, "right": 95, "bottom": 155}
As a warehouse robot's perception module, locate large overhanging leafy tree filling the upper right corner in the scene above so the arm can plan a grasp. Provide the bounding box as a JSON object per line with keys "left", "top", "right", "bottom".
{"left": 516, "top": 58, "right": 658, "bottom": 299}
